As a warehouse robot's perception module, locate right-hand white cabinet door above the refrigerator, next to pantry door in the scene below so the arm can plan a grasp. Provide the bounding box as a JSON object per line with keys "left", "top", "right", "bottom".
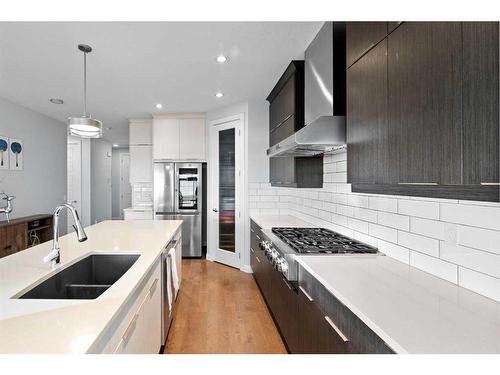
{"left": 179, "top": 118, "right": 205, "bottom": 160}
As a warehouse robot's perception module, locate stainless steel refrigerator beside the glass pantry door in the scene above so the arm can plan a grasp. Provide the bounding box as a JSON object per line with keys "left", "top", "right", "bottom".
{"left": 153, "top": 162, "right": 203, "bottom": 258}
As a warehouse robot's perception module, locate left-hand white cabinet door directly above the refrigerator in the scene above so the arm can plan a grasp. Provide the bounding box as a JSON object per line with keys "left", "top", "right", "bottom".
{"left": 153, "top": 118, "right": 179, "bottom": 160}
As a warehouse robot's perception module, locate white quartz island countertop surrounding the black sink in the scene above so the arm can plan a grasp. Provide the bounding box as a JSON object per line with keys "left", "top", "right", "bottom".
{"left": 0, "top": 220, "right": 182, "bottom": 353}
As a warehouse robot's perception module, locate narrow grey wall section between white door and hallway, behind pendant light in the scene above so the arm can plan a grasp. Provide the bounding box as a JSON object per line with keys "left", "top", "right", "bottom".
{"left": 90, "top": 139, "right": 112, "bottom": 224}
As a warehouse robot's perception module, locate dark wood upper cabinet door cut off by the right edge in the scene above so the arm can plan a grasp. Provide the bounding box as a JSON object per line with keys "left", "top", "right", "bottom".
{"left": 462, "top": 22, "right": 499, "bottom": 184}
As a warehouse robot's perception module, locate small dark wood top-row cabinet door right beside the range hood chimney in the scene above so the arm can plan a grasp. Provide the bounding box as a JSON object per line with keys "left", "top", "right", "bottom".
{"left": 346, "top": 22, "right": 387, "bottom": 67}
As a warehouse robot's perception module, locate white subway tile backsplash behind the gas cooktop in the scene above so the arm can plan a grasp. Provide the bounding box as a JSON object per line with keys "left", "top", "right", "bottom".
{"left": 249, "top": 151, "right": 500, "bottom": 301}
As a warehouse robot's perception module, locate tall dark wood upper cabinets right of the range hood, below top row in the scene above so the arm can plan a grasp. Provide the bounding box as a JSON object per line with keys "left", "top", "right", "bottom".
{"left": 347, "top": 22, "right": 500, "bottom": 202}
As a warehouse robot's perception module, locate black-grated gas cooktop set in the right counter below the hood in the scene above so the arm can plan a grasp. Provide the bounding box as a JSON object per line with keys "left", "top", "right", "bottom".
{"left": 272, "top": 227, "right": 378, "bottom": 254}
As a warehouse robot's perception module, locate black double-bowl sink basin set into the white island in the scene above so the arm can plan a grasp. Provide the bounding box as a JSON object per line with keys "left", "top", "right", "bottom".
{"left": 19, "top": 254, "right": 139, "bottom": 299}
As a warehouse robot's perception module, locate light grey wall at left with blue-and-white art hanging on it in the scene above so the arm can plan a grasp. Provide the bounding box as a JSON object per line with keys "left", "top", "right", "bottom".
{"left": 0, "top": 98, "right": 67, "bottom": 231}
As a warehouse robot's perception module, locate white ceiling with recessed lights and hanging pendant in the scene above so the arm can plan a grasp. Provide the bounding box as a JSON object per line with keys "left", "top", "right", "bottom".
{"left": 0, "top": 22, "right": 321, "bottom": 144}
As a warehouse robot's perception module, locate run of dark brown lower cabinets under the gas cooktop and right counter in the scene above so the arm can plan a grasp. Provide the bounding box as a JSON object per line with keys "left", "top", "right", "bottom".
{"left": 250, "top": 221, "right": 393, "bottom": 354}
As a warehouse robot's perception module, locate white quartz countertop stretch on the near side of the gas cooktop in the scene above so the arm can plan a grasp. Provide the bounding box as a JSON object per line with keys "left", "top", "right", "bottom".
{"left": 297, "top": 255, "right": 500, "bottom": 353}
